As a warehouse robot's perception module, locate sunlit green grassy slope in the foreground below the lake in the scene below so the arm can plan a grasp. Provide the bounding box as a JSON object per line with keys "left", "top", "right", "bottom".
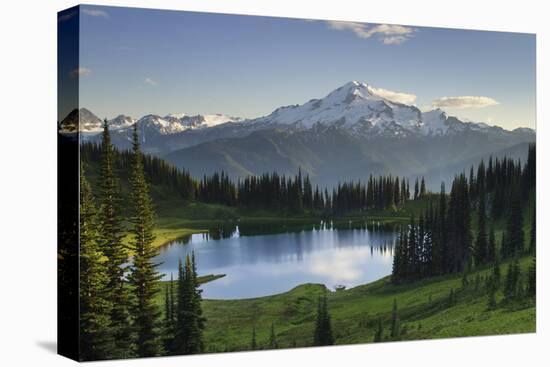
{"left": 187, "top": 257, "right": 535, "bottom": 350}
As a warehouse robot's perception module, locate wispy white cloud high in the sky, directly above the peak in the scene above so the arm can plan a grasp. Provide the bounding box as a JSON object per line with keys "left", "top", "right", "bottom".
{"left": 327, "top": 20, "right": 415, "bottom": 45}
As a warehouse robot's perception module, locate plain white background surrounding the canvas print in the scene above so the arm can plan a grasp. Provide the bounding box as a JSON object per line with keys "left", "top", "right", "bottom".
{"left": 0, "top": 0, "right": 550, "bottom": 367}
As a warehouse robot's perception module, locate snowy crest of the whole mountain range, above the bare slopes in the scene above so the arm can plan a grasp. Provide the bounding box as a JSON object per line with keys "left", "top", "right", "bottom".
{"left": 61, "top": 81, "right": 534, "bottom": 141}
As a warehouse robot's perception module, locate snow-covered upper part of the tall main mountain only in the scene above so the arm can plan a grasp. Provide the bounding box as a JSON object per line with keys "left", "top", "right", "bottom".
{"left": 252, "top": 81, "right": 520, "bottom": 137}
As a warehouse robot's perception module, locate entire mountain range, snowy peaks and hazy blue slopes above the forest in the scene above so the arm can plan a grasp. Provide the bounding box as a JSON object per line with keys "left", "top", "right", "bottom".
{"left": 60, "top": 81, "right": 535, "bottom": 189}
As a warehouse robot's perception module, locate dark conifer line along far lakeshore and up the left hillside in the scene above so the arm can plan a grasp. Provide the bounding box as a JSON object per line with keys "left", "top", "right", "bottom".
{"left": 81, "top": 142, "right": 436, "bottom": 216}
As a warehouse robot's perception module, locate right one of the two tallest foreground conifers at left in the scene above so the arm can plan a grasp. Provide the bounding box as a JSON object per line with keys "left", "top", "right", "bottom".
{"left": 128, "top": 124, "right": 162, "bottom": 357}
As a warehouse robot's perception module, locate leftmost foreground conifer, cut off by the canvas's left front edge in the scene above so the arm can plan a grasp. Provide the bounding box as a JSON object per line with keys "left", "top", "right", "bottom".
{"left": 79, "top": 170, "right": 115, "bottom": 360}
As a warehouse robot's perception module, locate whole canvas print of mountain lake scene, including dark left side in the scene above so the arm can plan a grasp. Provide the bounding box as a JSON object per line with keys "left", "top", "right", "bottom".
{"left": 57, "top": 5, "right": 536, "bottom": 361}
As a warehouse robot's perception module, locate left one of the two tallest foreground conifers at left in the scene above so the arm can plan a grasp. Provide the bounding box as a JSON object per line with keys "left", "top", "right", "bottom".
{"left": 98, "top": 120, "right": 133, "bottom": 358}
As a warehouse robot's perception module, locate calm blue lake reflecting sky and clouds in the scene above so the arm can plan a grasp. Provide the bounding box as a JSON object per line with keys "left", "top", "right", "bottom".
{"left": 156, "top": 224, "right": 395, "bottom": 299}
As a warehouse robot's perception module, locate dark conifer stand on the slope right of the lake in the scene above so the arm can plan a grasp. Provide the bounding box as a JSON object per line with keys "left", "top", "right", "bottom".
{"left": 392, "top": 145, "right": 536, "bottom": 283}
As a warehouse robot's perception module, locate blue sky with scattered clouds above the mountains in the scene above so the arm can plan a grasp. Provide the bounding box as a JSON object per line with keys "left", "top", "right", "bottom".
{"left": 73, "top": 6, "right": 536, "bottom": 129}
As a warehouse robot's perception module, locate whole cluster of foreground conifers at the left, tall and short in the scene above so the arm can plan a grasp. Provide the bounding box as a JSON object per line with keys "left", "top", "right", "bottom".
{"left": 79, "top": 122, "right": 204, "bottom": 360}
